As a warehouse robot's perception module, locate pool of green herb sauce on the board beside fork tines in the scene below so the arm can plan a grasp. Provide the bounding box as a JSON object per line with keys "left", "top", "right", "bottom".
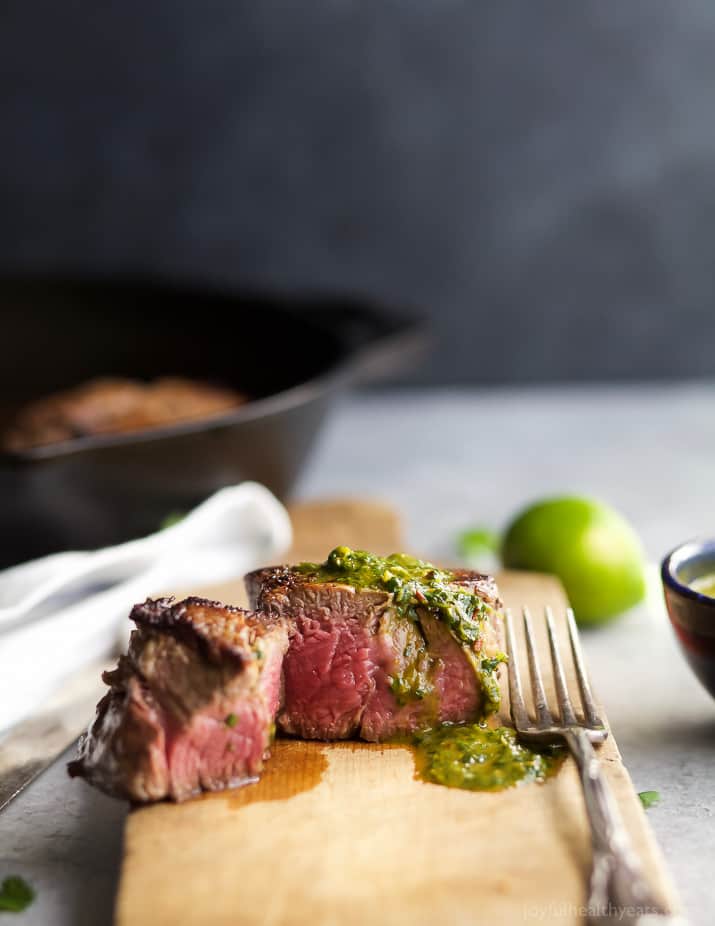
{"left": 415, "top": 723, "right": 565, "bottom": 791}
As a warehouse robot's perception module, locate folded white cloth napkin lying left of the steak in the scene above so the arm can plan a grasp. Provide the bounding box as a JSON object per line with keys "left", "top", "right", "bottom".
{"left": 0, "top": 482, "right": 291, "bottom": 731}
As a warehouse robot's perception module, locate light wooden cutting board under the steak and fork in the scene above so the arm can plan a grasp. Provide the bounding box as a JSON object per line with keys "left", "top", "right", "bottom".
{"left": 116, "top": 503, "right": 679, "bottom": 926}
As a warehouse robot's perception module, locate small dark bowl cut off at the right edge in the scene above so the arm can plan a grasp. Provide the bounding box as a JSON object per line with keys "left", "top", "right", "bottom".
{"left": 661, "top": 540, "right": 715, "bottom": 698}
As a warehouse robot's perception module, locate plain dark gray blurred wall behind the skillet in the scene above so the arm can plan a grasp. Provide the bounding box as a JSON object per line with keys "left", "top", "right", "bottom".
{"left": 0, "top": 0, "right": 715, "bottom": 382}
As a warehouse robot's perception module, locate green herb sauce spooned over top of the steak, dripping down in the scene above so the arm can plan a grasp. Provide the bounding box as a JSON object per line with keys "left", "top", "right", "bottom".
{"left": 295, "top": 547, "right": 506, "bottom": 716}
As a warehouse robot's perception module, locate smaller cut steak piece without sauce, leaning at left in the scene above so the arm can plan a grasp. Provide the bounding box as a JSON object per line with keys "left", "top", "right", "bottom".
{"left": 68, "top": 598, "right": 288, "bottom": 802}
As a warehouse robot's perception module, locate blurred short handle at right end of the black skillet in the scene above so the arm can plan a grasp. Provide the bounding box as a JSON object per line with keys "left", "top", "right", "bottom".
{"left": 303, "top": 303, "right": 430, "bottom": 386}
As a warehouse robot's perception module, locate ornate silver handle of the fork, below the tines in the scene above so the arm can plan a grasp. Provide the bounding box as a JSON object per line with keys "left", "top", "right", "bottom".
{"left": 565, "top": 727, "right": 685, "bottom": 926}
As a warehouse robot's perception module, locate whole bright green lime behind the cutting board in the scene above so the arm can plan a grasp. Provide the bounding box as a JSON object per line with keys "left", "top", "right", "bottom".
{"left": 502, "top": 497, "right": 645, "bottom": 624}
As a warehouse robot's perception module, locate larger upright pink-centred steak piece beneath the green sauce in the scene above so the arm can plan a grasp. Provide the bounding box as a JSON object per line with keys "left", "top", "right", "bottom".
{"left": 246, "top": 548, "right": 503, "bottom": 742}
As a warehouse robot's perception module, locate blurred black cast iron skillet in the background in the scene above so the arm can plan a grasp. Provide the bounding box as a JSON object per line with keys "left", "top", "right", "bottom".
{"left": 0, "top": 279, "right": 425, "bottom": 566}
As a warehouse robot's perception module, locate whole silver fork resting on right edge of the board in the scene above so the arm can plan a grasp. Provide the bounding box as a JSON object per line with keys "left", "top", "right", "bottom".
{"left": 505, "top": 607, "right": 685, "bottom": 926}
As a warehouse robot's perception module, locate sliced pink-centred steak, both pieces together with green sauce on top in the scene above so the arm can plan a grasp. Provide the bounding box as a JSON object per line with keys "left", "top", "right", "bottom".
{"left": 69, "top": 547, "right": 504, "bottom": 802}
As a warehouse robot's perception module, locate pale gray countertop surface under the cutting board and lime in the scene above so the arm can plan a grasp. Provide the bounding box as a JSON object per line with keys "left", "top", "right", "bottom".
{"left": 0, "top": 385, "right": 715, "bottom": 926}
